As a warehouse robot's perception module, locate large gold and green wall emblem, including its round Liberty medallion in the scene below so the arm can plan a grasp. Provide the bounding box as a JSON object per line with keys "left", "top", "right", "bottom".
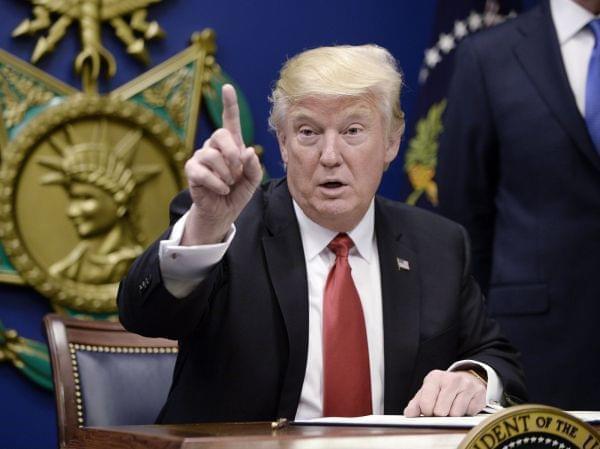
{"left": 0, "top": 0, "right": 230, "bottom": 316}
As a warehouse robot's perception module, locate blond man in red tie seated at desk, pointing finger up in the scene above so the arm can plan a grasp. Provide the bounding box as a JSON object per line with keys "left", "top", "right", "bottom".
{"left": 118, "top": 45, "right": 525, "bottom": 422}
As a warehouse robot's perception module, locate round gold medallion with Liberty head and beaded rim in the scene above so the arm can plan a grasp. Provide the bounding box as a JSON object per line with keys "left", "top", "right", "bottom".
{"left": 0, "top": 95, "right": 186, "bottom": 313}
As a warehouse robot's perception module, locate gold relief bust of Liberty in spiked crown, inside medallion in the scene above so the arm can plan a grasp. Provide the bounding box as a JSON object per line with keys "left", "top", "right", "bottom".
{"left": 39, "top": 123, "right": 159, "bottom": 284}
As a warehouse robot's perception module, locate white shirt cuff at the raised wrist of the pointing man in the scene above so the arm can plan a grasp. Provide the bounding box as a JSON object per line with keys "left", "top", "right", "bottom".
{"left": 158, "top": 212, "right": 235, "bottom": 298}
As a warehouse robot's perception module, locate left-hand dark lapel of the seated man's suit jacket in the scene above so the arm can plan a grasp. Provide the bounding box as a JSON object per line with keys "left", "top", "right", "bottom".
{"left": 262, "top": 182, "right": 308, "bottom": 418}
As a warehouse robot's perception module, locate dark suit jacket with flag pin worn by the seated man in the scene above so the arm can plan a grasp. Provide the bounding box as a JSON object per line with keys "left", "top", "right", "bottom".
{"left": 119, "top": 180, "right": 525, "bottom": 422}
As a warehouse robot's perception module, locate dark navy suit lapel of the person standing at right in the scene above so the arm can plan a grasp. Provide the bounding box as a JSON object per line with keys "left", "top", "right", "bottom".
{"left": 514, "top": 2, "right": 600, "bottom": 170}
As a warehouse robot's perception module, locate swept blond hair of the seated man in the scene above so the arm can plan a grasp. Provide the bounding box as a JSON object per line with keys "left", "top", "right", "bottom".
{"left": 269, "top": 45, "right": 404, "bottom": 135}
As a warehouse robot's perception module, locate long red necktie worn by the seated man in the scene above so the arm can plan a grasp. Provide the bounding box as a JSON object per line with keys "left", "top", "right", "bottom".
{"left": 323, "top": 234, "right": 371, "bottom": 416}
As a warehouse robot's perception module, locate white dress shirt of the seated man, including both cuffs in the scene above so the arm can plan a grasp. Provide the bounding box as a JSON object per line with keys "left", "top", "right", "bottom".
{"left": 159, "top": 201, "right": 504, "bottom": 419}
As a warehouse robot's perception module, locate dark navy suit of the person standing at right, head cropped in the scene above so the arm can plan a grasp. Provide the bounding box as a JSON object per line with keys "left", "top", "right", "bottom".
{"left": 437, "top": 1, "right": 600, "bottom": 410}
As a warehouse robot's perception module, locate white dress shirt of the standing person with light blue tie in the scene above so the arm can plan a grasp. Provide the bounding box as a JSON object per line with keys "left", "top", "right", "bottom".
{"left": 550, "top": 0, "right": 600, "bottom": 117}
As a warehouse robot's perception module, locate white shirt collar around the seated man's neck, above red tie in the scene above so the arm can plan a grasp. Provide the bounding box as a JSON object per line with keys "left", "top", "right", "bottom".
{"left": 293, "top": 200, "right": 375, "bottom": 263}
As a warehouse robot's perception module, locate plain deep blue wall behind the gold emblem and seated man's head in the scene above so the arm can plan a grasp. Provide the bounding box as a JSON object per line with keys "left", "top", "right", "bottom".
{"left": 0, "top": 0, "right": 520, "bottom": 449}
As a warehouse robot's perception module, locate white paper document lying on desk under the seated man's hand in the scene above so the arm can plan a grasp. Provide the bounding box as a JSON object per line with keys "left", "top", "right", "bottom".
{"left": 293, "top": 411, "right": 600, "bottom": 429}
